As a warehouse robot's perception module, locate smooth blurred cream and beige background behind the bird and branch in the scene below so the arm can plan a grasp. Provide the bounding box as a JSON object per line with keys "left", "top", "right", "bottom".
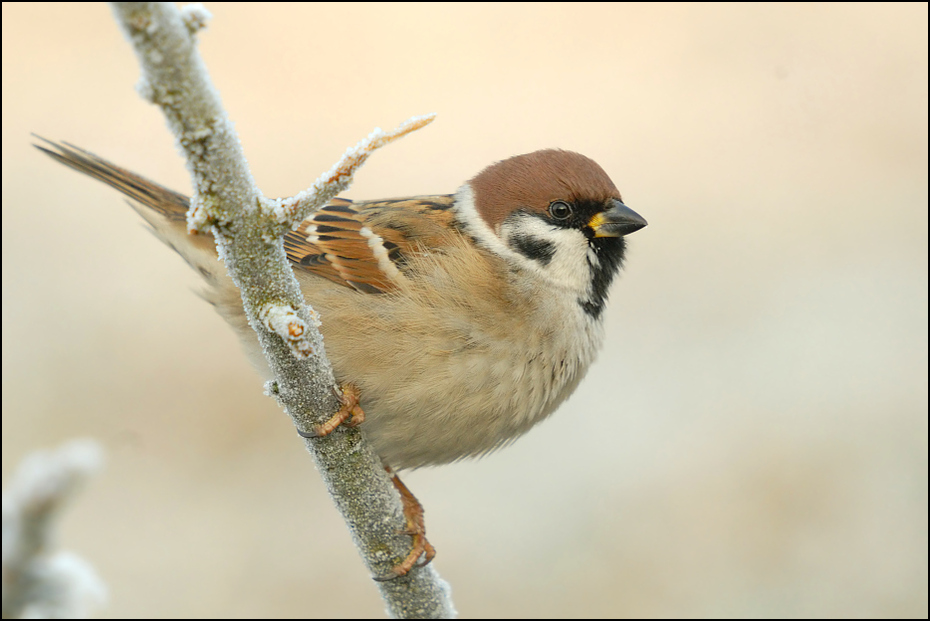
{"left": 2, "top": 3, "right": 928, "bottom": 618}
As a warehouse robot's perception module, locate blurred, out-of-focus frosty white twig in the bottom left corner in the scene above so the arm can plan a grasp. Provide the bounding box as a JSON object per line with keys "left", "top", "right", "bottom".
{"left": 3, "top": 440, "right": 106, "bottom": 619}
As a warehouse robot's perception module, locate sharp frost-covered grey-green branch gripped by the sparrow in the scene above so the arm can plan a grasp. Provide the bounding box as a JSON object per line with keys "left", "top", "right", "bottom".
{"left": 106, "top": 2, "right": 454, "bottom": 617}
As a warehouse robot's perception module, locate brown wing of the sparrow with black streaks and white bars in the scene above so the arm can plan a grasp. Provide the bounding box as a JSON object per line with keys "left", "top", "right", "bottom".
{"left": 284, "top": 195, "right": 454, "bottom": 293}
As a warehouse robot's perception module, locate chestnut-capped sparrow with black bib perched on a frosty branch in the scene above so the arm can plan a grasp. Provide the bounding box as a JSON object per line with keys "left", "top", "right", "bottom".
{"left": 35, "top": 138, "right": 647, "bottom": 579}
